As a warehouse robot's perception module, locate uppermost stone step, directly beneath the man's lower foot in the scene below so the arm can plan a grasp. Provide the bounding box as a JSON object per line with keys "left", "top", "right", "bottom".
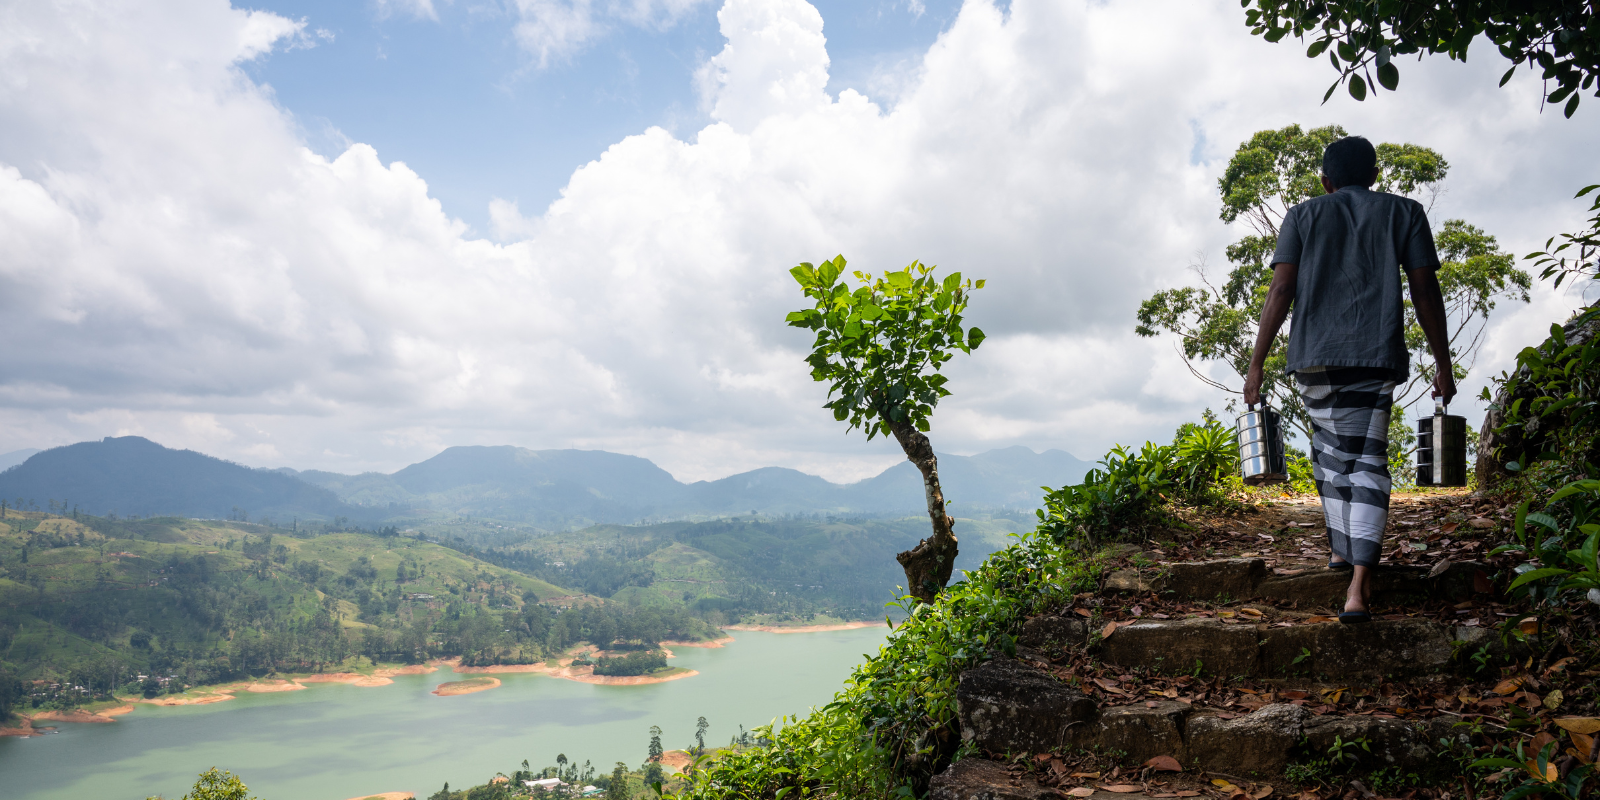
{"left": 1104, "top": 558, "right": 1488, "bottom": 605}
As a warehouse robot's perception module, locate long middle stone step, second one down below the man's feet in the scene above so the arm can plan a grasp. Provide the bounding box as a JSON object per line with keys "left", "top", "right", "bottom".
{"left": 1018, "top": 616, "right": 1498, "bottom": 680}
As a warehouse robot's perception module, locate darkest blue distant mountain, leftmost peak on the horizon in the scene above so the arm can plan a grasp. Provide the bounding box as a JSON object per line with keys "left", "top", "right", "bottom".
{"left": 0, "top": 437, "right": 374, "bottom": 522}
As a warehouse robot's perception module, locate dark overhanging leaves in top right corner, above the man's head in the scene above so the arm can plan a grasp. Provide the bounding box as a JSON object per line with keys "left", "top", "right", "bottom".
{"left": 1243, "top": 0, "right": 1600, "bottom": 117}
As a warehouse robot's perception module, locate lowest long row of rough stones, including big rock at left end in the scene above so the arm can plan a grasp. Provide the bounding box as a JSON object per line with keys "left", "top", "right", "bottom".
{"left": 952, "top": 659, "right": 1459, "bottom": 784}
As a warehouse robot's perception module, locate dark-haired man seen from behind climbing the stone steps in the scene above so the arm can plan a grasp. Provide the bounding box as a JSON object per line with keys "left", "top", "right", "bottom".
{"left": 1245, "top": 136, "right": 1456, "bottom": 622}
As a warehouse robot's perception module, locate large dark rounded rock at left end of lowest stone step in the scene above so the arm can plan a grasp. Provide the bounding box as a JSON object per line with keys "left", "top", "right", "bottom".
{"left": 955, "top": 659, "right": 1096, "bottom": 754}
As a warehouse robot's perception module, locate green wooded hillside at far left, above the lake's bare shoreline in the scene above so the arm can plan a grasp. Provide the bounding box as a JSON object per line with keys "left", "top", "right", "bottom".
{"left": 0, "top": 512, "right": 732, "bottom": 701}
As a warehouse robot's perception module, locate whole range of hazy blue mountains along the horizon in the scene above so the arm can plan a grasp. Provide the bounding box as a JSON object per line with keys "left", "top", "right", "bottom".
{"left": 0, "top": 437, "right": 1090, "bottom": 530}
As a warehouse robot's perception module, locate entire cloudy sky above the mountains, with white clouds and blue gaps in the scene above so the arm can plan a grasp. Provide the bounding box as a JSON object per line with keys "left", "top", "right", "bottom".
{"left": 0, "top": 0, "right": 1600, "bottom": 482}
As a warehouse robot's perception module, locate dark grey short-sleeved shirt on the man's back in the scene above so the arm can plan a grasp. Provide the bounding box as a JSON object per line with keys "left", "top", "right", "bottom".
{"left": 1272, "top": 186, "right": 1438, "bottom": 381}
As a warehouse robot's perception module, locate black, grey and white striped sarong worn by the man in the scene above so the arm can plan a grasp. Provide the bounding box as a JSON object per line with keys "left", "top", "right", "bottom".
{"left": 1294, "top": 366, "right": 1398, "bottom": 566}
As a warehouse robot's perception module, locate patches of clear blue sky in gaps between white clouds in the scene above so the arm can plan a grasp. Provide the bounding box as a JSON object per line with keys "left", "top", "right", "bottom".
{"left": 246, "top": 0, "right": 960, "bottom": 232}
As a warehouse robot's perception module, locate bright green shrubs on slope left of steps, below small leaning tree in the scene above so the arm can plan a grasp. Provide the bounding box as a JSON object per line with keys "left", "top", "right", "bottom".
{"left": 667, "top": 531, "right": 1104, "bottom": 800}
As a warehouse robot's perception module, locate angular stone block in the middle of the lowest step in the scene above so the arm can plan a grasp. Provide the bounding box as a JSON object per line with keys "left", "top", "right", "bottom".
{"left": 1184, "top": 704, "right": 1312, "bottom": 778}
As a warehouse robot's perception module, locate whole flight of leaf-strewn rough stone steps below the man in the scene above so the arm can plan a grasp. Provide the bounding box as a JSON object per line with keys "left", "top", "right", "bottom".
{"left": 928, "top": 558, "right": 1501, "bottom": 800}
